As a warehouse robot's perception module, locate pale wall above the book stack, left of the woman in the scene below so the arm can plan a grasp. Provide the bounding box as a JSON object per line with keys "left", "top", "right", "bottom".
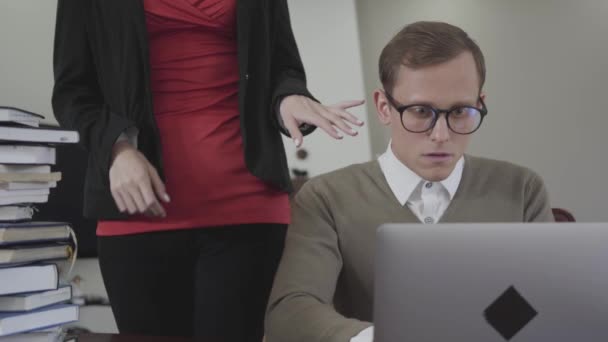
{"left": 0, "top": 0, "right": 57, "bottom": 124}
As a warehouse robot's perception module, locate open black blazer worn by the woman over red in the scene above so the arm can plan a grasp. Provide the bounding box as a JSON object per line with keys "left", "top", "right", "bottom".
{"left": 53, "top": 0, "right": 312, "bottom": 219}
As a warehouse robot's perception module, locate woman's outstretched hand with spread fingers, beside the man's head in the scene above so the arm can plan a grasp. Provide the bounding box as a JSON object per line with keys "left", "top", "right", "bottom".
{"left": 279, "top": 95, "right": 365, "bottom": 147}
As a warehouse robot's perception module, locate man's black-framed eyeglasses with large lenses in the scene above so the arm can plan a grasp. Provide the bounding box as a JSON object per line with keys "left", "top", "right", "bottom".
{"left": 384, "top": 91, "right": 488, "bottom": 134}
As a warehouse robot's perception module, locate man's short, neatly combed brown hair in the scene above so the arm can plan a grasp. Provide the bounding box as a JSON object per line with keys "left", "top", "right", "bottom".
{"left": 379, "top": 21, "right": 486, "bottom": 92}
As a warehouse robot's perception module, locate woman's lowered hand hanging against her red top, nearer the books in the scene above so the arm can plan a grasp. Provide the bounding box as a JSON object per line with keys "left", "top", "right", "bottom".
{"left": 110, "top": 141, "right": 170, "bottom": 217}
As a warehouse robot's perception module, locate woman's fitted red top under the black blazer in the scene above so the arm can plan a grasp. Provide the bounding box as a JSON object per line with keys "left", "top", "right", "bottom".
{"left": 97, "top": 0, "right": 290, "bottom": 236}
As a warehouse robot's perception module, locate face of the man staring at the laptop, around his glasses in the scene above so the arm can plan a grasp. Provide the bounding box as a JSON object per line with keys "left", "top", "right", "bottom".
{"left": 374, "top": 52, "right": 484, "bottom": 182}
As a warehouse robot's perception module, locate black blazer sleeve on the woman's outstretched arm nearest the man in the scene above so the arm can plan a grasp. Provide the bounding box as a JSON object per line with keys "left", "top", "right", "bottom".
{"left": 270, "top": 0, "right": 318, "bottom": 136}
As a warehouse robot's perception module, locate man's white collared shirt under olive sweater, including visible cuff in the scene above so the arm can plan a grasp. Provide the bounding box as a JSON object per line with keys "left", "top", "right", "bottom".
{"left": 350, "top": 143, "right": 464, "bottom": 342}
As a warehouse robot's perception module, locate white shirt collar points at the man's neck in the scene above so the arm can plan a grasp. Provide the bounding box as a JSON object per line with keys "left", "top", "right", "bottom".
{"left": 378, "top": 142, "right": 464, "bottom": 205}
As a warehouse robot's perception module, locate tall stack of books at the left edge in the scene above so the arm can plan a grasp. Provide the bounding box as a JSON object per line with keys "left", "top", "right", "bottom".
{"left": 0, "top": 107, "right": 79, "bottom": 342}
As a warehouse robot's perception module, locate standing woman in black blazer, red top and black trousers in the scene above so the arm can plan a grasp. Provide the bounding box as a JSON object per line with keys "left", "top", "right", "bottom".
{"left": 53, "top": 0, "right": 362, "bottom": 341}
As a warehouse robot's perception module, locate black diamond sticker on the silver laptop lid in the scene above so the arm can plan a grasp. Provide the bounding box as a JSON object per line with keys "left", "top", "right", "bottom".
{"left": 484, "top": 286, "right": 538, "bottom": 341}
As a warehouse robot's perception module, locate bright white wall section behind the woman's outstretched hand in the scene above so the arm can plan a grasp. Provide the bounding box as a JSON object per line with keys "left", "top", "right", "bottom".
{"left": 284, "top": 0, "right": 371, "bottom": 175}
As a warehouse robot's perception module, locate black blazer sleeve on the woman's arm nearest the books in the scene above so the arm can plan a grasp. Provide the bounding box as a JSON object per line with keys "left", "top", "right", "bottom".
{"left": 52, "top": 0, "right": 134, "bottom": 180}
